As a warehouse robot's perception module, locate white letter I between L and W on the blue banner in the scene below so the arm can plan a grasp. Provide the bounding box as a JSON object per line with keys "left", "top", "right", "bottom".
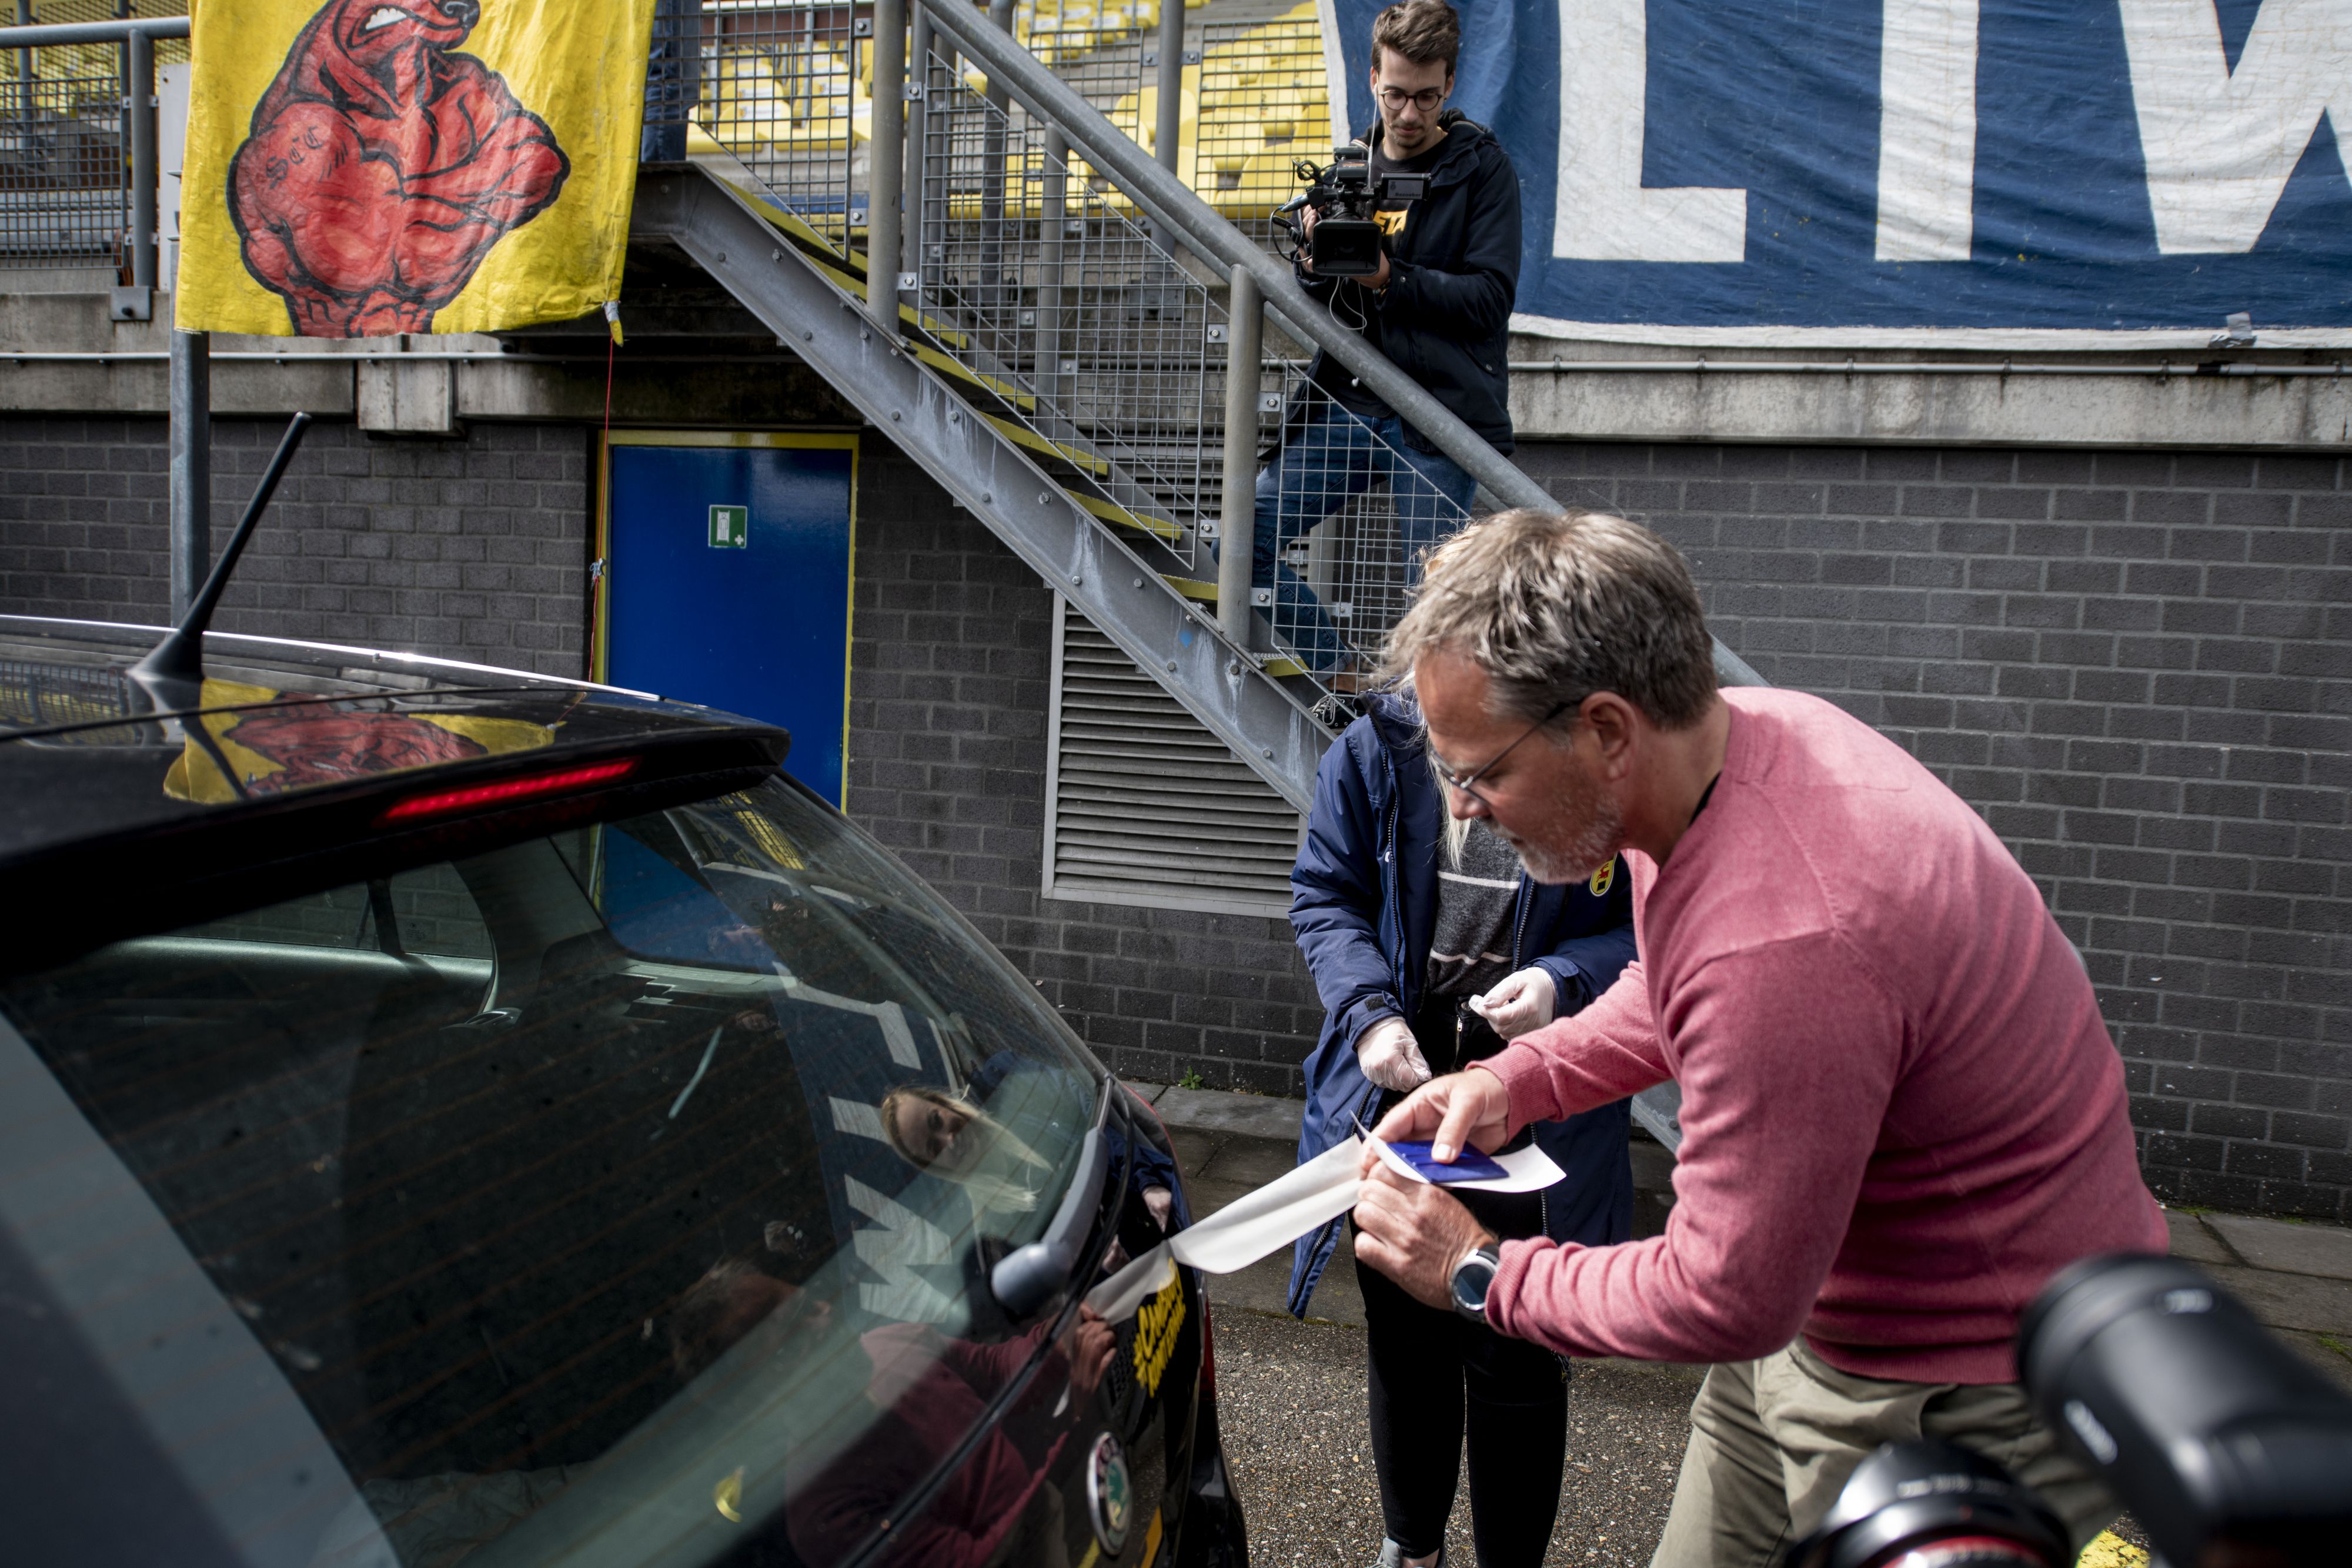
{"left": 1877, "top": 0, "right": 1976, "bottom": 261}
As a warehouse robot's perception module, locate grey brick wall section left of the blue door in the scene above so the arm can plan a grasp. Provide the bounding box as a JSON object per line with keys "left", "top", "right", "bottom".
{"left": 0, "top": 419, "right": 590, "bottom": 675}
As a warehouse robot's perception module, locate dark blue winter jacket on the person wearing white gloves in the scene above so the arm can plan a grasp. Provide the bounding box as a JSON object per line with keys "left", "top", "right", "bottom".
{"left": 1289, "top": 694, "right": 1635, "bottom": 1316}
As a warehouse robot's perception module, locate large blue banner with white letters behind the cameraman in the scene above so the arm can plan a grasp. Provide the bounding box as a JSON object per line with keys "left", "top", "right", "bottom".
{"left": 1327, "top": 0, "right": 2352, "bottom": 346}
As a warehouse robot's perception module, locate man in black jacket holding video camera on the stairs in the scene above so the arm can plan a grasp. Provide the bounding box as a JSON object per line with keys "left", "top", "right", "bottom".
{"left": 1251, "top": 0, "right": 1519, "bottom": 677}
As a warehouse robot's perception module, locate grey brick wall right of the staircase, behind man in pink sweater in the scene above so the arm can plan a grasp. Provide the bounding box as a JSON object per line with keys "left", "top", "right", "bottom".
{"left": 1519, "top": 444, "right": 2352, "bottom": 1220}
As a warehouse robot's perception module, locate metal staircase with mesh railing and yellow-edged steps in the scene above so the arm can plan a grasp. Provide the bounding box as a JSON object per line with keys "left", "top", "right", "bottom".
{"left": 633, "top": 0, "right": 1755, "bottom": 811}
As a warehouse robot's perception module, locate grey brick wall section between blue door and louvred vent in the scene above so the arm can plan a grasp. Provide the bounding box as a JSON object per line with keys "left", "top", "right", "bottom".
{"left": 849, "top": 437, "right": 1322, "bottom": 1093}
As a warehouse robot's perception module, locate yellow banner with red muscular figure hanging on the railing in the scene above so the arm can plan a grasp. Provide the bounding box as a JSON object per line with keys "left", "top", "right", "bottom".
{"left": 176, "top": 0, "right": 654, "bottom": 339}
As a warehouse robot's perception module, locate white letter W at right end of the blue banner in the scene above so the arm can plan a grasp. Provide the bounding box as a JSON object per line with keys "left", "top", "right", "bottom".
{"left": 2122, "top": 0, "right": 2352, "bottom": 256}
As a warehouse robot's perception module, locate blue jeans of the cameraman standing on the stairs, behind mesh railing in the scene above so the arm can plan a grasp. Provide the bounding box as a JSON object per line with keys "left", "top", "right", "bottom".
{"left": 1249, "top": 400, "right": 1477, "bottom": 675}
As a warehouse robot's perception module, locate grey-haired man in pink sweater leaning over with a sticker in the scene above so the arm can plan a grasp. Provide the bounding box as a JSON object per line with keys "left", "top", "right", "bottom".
{"left": 1355, "top": 510, "right": 2166, "bottom": 1568}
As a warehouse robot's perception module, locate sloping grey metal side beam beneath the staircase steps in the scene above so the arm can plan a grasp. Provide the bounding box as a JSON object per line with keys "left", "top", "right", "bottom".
{"left": 630, "top": 169, "right": 1331, "bottom": 811}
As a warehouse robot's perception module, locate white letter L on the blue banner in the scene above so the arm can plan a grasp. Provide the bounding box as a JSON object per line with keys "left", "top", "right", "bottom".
{"left": 1552, "top": 0, "right": 1748, "bottom": 261}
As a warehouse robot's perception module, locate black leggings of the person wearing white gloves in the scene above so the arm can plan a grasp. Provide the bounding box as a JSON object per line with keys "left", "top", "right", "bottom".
{"left": 1357, "top": 1192, "right": 1569, "bottom": 1568}
